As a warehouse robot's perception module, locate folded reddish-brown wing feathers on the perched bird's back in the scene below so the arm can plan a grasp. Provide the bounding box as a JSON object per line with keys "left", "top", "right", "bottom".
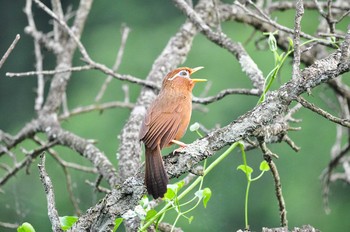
{"left": 140, "top": 105, "right": 182, "bottom": 149}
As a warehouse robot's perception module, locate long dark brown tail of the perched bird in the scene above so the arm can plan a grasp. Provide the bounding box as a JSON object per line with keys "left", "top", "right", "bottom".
{"left": 145, "top": 146, "right": 169, "bottom": 199}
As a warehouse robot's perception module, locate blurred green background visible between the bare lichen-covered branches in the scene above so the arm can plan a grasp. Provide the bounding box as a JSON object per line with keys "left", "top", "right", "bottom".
{"left": 0, "top": 0, "right": 350, "bottom": 231}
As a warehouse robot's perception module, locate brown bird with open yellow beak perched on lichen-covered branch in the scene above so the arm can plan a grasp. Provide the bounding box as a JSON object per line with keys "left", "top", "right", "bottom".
{"left": 140, "top": 67, "right": 206, "bottom": 199}
